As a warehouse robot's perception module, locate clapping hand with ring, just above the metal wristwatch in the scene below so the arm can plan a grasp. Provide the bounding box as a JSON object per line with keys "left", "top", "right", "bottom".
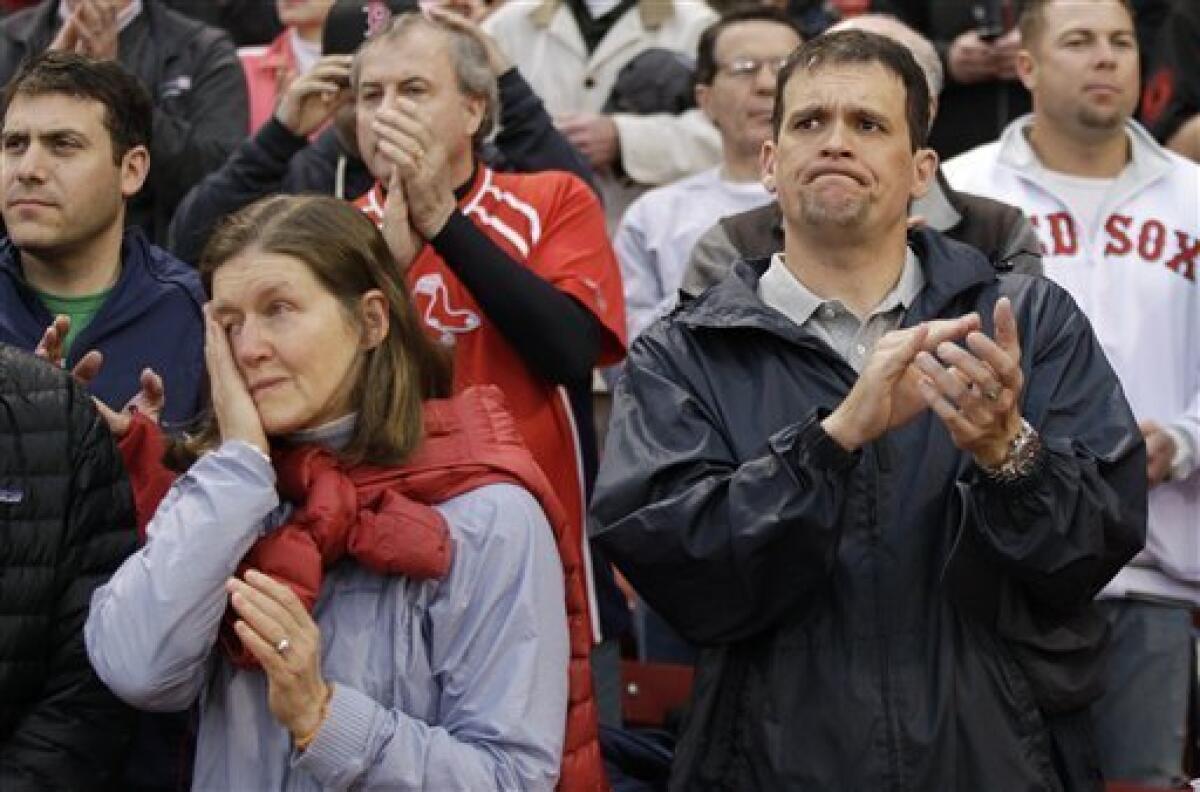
{"left": 916, "top": 298, "right": 1025, "bottom": 468}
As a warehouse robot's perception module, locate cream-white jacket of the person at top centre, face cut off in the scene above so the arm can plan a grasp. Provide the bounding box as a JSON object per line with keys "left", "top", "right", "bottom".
{"left": 484, "top": 0, "right": 721, "bottom": 219}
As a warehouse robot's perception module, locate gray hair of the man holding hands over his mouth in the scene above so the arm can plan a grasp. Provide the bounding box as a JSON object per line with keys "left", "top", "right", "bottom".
{"left": 350, "top": 11, "right": 500, "bottom": 151}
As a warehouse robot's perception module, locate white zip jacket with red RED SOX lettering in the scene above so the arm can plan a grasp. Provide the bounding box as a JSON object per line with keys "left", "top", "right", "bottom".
{"left": 944, "top": 116, "right": 1200, "bottom": 605}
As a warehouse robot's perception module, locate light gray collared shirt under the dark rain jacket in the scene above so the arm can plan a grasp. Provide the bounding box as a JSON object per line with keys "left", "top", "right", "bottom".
{"left": 758, "top": 247, "right": 925, "bottom": 373}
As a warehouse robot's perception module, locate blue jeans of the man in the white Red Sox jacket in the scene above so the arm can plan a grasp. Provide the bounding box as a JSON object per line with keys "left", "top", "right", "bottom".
{"left": 1092, "top": 599, "right": 1194, "bottom": 786}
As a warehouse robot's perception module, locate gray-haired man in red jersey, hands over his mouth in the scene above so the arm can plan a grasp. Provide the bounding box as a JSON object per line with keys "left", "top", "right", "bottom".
{"left": 350, "top": 13, "right": 625, "bottom": 777}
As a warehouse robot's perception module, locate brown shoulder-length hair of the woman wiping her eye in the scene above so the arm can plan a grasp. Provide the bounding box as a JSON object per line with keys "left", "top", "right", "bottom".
{"left": 187, "top": 196, "right": 451, "bottom": 466}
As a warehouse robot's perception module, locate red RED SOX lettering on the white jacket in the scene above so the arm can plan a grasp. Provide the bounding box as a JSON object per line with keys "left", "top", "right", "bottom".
{"left": 1030, "top": 211, "right": 1200, "bottom": 283}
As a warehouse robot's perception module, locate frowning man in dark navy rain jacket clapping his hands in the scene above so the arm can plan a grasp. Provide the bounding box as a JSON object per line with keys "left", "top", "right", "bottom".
{"left": 593, "top": 31, "right": 1146, "bottom": 792}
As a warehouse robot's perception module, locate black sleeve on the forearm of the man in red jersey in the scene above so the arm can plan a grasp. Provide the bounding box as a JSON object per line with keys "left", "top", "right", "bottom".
{"left": 430, "top": 209, "right": 601, "bottom": 384}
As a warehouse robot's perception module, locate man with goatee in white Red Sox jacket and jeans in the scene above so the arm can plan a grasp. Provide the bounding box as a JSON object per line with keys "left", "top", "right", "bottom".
{"left": 946, "top": 0, "right": 1200, "bottom": 786}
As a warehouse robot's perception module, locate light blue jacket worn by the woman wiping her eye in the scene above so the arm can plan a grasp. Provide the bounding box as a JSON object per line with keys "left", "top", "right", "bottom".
{"left": 85, "top": 442, "right": 569, "bottom": 792}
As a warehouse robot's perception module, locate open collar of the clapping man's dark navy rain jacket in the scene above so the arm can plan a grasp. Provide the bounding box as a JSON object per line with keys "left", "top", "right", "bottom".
{"left": 676, "top": 228, "right": 997, "bottom": 342}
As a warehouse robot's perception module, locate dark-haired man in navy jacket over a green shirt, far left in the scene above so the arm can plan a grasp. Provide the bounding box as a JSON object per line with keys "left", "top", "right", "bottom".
{"left": 0, "top": 53, "right": 204, "bottom": 425}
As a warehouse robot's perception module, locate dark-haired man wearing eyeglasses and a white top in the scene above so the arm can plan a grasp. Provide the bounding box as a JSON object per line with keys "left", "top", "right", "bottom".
{"left": 613, "top": 7, "right": 800, "bottom": 338}
